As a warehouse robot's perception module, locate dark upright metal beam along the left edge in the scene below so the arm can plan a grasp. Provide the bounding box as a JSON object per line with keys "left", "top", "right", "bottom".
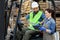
{"left": 0, "top": 0, "right": 5, "bottom": 40}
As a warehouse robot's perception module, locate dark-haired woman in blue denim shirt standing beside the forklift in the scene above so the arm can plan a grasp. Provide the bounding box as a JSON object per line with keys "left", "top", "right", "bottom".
{"left": 39, "top": 9, "right": 56, "bottom": 40}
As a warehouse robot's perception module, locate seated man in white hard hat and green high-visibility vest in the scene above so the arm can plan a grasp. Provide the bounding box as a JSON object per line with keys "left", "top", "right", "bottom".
{"left": 22, "top": 2, "right": 45, "bottom": 40}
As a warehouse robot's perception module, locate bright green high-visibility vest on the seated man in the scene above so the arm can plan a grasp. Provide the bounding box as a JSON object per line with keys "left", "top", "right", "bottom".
{"left": 28, "top": 11, "right": 42, "bottom": 30}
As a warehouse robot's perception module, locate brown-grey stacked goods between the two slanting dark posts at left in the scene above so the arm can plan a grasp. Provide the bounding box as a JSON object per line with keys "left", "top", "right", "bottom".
{"left": 9, "top": 7, "right": 19, "bottom": 29}
